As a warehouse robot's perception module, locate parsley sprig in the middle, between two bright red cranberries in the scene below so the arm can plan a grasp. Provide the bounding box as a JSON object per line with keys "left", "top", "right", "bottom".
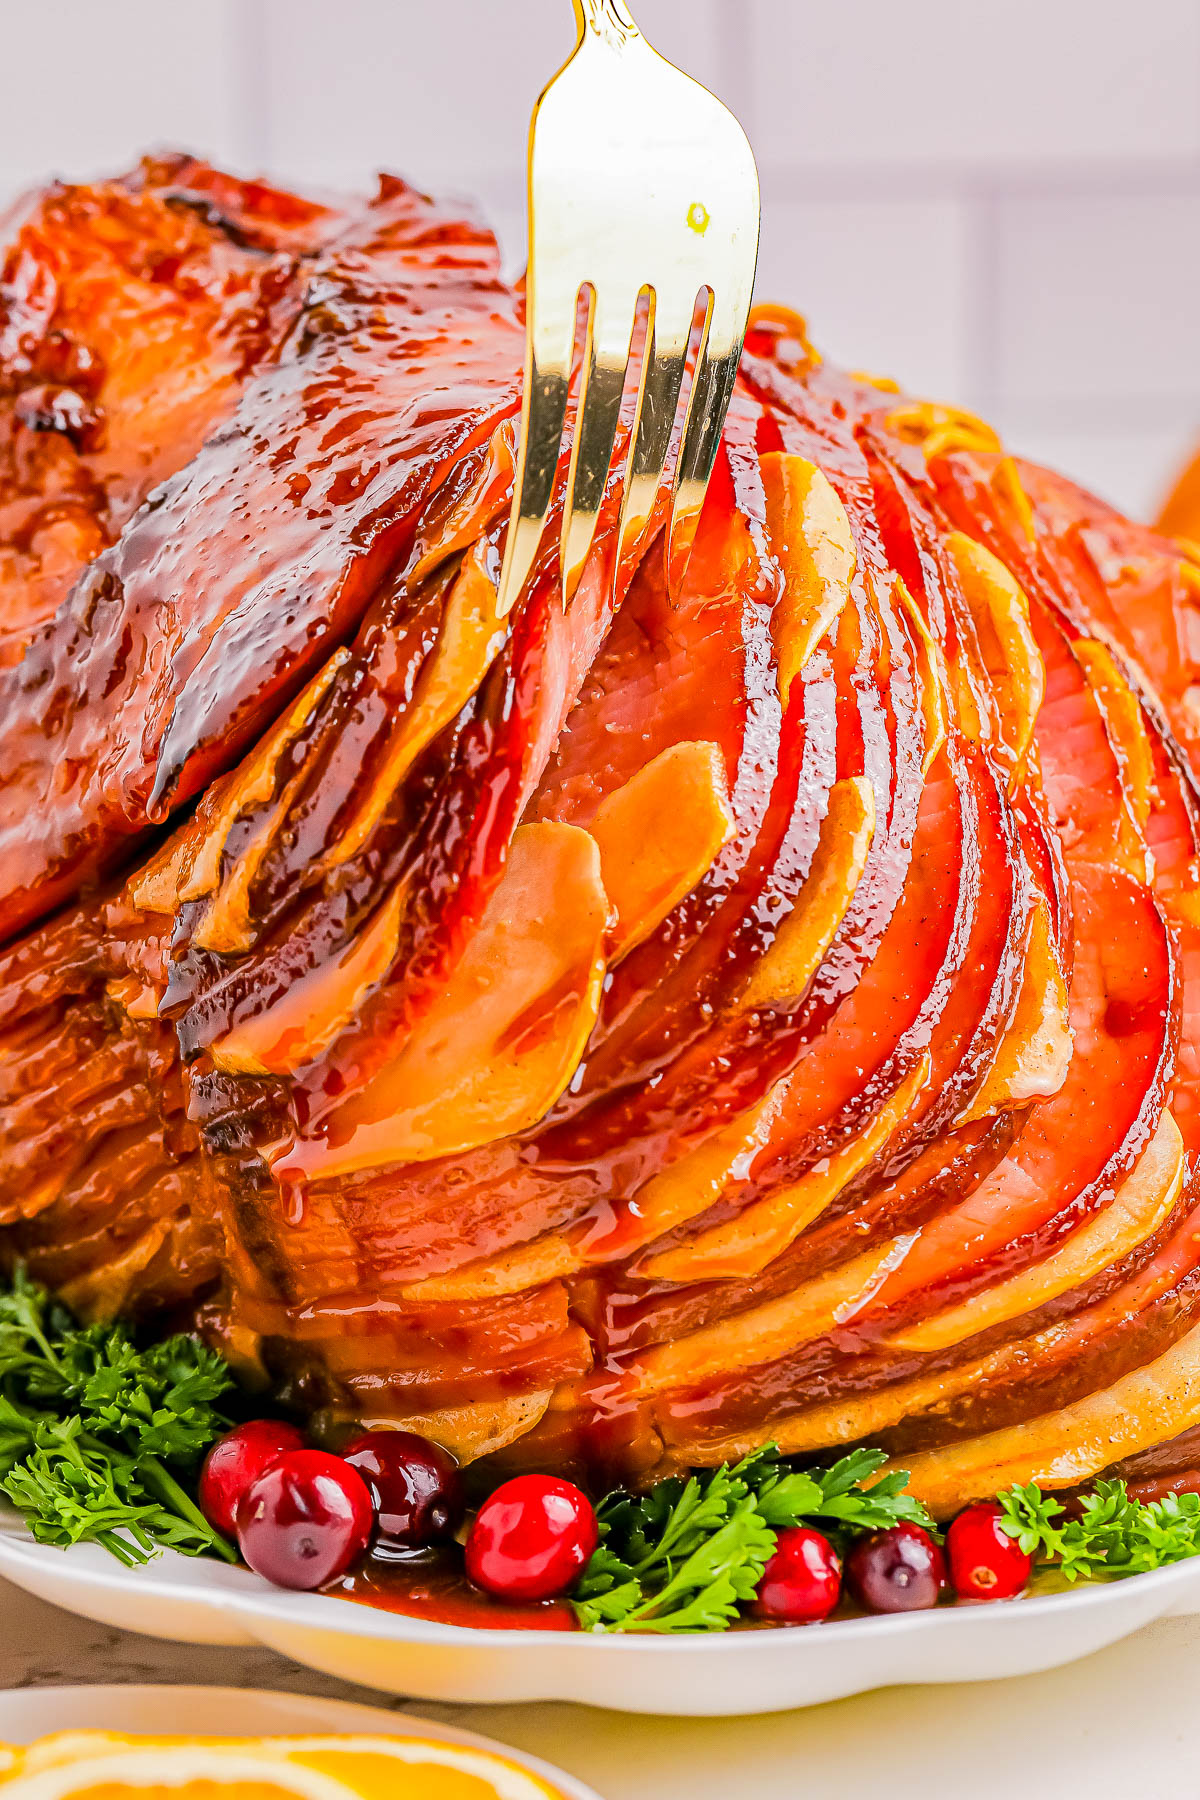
{"left": 574, "top": 1445, "right": 932, "bottom": 1633}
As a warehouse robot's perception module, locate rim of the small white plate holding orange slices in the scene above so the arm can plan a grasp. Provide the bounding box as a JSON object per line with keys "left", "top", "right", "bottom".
{"left": 0, "top": 1687, "right": 599, "bottom": 1800}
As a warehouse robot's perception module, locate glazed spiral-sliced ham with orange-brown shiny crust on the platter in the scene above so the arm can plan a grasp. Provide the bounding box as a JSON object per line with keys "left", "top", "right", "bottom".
{"left": 0, "top": 158, "right": 1200, "bottom": 1512}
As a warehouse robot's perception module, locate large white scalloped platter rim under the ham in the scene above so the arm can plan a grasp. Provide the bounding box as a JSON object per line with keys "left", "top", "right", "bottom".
{"left": 0, "top": 1521, "right": 1200, "bottom": 1715}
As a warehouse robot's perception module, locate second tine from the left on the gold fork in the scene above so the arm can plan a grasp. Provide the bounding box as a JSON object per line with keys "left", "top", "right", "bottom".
{"left": 561, "top": 290, "right": 635, "bottom": 596}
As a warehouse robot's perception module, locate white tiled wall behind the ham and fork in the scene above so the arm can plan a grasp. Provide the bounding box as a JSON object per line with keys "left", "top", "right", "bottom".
{"left": 0, "top": 0, "right": 1200, "bottom": 525}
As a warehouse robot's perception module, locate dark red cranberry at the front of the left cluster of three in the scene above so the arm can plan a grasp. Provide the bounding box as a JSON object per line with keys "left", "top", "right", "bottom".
{"left": 237, "top": 1451, "right": 372, "bottom": 1588}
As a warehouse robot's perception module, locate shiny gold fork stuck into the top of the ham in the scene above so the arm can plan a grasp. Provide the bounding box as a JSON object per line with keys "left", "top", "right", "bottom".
{"left": 498, "top": 0, "right": 759, "bottom": 616}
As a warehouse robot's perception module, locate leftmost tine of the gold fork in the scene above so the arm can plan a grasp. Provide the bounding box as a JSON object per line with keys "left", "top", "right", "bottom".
{"left": 497, "top": 295, "right": 576, "bottom": 619}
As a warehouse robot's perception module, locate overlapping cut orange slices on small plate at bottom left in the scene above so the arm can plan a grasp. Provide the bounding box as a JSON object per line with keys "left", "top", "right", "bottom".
{"left": 0, "top": 1732, "right": 563, "bottom": 1800}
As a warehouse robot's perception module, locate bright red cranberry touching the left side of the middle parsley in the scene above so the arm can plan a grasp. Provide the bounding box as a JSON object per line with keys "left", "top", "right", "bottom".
{"left": 466, "top": 1474, "right": 599, "bottom": 1600}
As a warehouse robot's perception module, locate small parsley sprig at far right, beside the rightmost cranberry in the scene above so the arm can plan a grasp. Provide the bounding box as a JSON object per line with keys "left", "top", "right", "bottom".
{"left": 999, "top": 1481, "right": 1200, "bottom": 1582}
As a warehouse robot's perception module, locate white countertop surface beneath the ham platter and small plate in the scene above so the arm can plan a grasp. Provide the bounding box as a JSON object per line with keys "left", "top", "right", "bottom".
{"left": 0, "top": 1582, "right": 1200, "bottom": 1800}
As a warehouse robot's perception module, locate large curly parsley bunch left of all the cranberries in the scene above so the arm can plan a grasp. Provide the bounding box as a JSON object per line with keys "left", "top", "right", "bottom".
{"left": 0, "top": 1269, "right": 237, "bottom": 1566}
